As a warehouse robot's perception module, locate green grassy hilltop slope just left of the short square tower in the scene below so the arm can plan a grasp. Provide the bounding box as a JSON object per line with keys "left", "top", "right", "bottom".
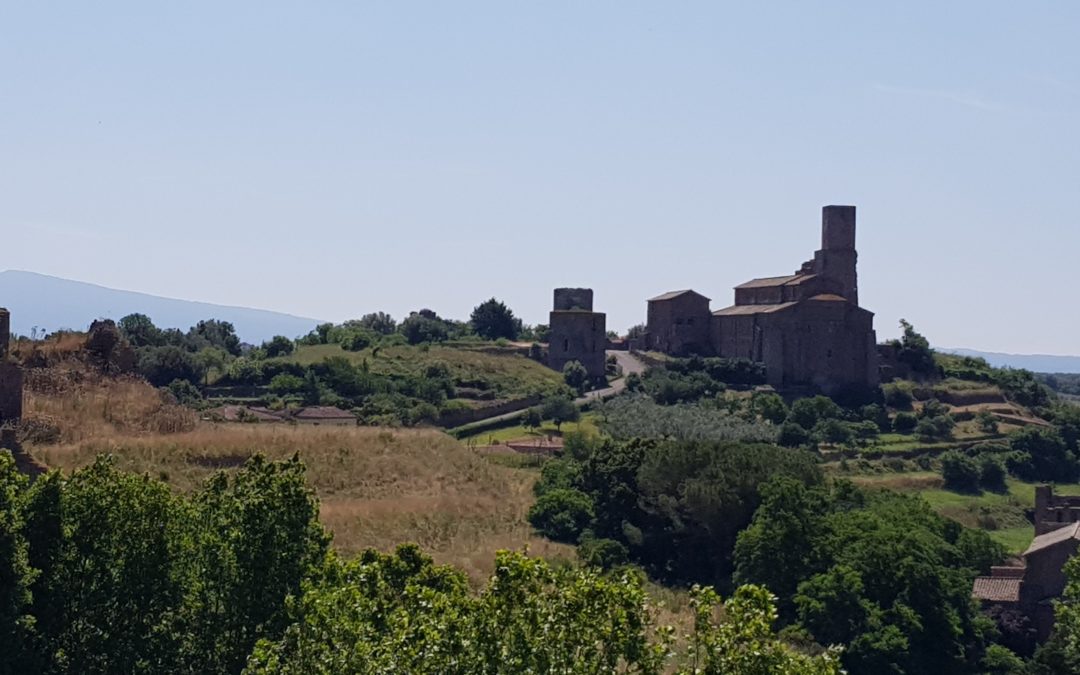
{"left": 274, "top": 345, "right": 563, "bottom": 399}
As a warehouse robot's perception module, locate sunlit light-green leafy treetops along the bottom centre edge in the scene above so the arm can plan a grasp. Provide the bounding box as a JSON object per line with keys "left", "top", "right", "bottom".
{"left": 247, "top": 546, "right": 839, "bottom": 675}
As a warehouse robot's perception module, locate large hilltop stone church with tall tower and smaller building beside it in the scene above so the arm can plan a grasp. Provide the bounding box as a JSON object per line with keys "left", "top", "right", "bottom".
{"left": 646, "top": 206, "right": 878, "bottom": 393}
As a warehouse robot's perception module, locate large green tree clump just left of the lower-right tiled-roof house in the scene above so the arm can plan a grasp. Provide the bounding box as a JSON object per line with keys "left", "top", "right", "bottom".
{"left": 734, "top": 477, "right": 1003, "bottom": 675}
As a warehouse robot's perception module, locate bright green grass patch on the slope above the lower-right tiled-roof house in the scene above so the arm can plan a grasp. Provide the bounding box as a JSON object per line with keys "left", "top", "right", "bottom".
{"left": 851, "top": 471, "right": 1080, "bottom": 553}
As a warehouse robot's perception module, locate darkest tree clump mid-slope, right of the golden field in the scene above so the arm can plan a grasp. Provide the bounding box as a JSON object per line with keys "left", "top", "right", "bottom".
{"left": 529, "top": 440, "right": 822, "bottom": 584}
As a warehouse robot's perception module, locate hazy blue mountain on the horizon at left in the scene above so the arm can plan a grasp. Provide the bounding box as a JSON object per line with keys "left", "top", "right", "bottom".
{"left": 0, "top": 270, "right": 321, "bottom": 343}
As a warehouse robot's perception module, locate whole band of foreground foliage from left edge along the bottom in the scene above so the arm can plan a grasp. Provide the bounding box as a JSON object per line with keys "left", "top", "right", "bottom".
{"left": 0, "top": 453, "right": 839, "bottom": 675}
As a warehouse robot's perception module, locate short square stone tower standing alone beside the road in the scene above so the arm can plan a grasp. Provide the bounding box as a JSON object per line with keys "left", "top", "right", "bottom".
{"left": 548, "top": 288, "right": 607, "bottom": 380}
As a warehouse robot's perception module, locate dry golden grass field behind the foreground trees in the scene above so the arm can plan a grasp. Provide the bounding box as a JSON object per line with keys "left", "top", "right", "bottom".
{"left": 33, "top": 423, "right": 573, "bottom": 583}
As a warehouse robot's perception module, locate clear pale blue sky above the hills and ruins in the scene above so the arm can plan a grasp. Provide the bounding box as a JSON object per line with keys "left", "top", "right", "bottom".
{"left": 0, "top": 0, "right": 1080, "bottom": 354}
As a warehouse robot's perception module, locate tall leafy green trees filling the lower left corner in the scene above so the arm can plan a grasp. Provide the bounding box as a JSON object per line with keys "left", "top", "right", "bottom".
{"left": 0, "top": 453, "right": 328, "bottom": 673}
